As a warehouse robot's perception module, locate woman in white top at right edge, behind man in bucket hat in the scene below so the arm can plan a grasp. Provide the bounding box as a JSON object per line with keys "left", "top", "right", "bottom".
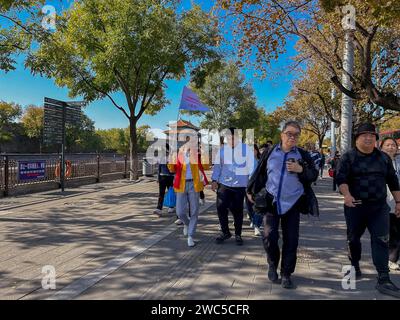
{"left": 381, "top": 137, "right": 400, "bottom": 270}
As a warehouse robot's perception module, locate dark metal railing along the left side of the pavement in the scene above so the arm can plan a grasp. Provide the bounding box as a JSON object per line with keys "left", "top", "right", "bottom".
{"left": 0, "top": 154, "right": 157, "bottom": 196}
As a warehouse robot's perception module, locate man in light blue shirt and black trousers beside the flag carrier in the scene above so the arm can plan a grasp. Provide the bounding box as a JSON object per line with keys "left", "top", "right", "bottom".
{"left": 211, "top": 128, "right": 255, "bottom": 245}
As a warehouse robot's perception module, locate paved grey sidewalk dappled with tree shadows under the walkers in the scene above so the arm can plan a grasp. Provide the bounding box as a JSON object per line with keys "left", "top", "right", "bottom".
{"left": 0, "top": 174, "right": 400, "bottom": 300}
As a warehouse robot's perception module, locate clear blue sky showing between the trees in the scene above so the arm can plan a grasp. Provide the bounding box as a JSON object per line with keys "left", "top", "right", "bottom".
{"left": 0, "top": 0, "right": 295, "bottom": 129}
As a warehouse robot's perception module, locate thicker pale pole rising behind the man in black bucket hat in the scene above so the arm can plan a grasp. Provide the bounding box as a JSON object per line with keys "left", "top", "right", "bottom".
{"left": 340, "top": 5, "right": 356, "bottom": 154}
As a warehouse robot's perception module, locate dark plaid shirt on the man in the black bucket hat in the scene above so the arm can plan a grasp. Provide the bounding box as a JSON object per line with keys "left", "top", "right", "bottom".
{"left": 336, "top": 148, "right": 400, "bottom": 202}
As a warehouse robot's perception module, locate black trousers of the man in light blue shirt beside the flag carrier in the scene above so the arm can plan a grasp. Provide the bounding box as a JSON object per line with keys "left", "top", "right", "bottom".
{"left": 217, "top": 184, "right": 246, "bottom": 236}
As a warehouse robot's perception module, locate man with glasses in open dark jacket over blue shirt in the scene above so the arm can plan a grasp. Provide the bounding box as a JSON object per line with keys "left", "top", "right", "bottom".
{"left": 246, "top": 121, "right": 318, "bottom": 289}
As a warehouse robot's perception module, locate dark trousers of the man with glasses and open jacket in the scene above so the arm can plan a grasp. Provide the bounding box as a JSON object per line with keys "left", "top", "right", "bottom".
{"left": 263, "top": 201, "right": 300, "bottom": 275}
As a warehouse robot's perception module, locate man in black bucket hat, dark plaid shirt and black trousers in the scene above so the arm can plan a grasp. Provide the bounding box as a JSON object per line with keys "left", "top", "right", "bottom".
{"left": 336, "top": 123, "right": 400, "bottom": 298}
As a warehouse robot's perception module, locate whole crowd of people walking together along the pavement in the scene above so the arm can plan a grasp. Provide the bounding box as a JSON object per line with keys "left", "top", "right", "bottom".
{"left": 155, "top": 121, "right": 400, "bottom": 298}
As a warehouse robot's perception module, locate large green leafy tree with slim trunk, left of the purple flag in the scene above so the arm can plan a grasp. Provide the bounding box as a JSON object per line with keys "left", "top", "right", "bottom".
{"left": 27, "top": 0, "right": 220, "bottom": 179}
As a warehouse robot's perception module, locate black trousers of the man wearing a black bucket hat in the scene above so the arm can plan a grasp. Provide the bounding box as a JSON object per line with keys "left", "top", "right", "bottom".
{"left": 344, "top": 201, "right": 390, "bottom": 273}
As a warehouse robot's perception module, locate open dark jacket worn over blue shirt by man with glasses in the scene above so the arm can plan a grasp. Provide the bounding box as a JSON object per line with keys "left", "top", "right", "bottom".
{"left": 246, "top": 145, "right": 319, "bottom": 216}
